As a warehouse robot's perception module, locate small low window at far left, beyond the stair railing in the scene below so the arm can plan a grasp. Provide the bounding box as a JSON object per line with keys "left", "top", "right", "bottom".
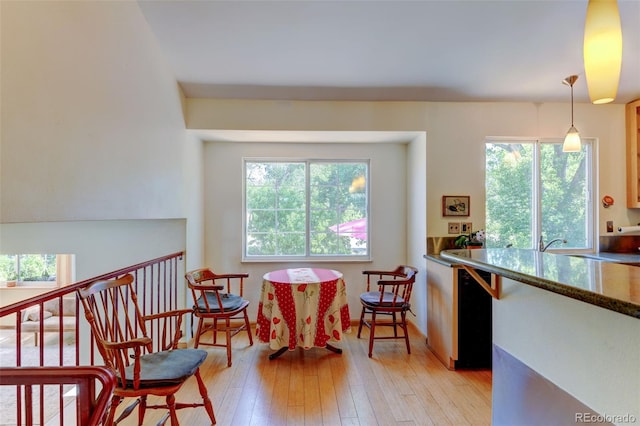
{"left": 0, "top": 254, "right": 73, "bottom": 286}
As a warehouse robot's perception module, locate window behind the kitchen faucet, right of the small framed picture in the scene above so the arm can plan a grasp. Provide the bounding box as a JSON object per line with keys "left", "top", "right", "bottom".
{"left": 485, "top": 139, "right": 595, "bottom": 250}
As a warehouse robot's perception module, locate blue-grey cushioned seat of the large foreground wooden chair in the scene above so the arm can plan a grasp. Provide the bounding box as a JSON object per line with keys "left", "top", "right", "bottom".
{"left": 120, "top": 349, "right": 207, "bottom": 388}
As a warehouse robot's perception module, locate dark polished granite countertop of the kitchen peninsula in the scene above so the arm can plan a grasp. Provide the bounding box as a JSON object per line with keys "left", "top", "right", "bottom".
{"left": 440, "top": 248, "right": 640, "bottom": 319}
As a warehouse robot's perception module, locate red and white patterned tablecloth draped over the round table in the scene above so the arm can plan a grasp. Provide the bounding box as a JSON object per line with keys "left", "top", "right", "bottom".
{"left": 256, "top": 268, "right": 351, "bottom": 350}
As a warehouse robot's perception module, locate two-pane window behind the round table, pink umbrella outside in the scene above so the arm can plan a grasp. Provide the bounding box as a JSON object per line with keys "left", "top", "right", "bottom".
{"left": 243, "top": 160, "right": 369, "bottom": 260}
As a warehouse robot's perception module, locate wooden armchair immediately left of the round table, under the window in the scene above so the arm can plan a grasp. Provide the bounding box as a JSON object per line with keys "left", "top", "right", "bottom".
{"left": 185, "top": 268, "right": 253, "bottom": 367}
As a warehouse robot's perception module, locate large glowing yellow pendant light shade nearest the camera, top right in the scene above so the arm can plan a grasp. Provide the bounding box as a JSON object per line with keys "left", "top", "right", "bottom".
{"left": 584, "top": 0, "right": 622, "bottom": 104}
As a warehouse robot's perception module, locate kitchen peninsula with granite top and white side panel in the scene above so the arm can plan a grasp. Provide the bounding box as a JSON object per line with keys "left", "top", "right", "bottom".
{"left": 438, "top": 248, "right": 640, "bottom": 426}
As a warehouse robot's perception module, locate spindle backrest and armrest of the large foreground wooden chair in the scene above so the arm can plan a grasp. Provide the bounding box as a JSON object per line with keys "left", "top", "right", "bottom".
{"left": 78, "top": 274, "right": 185, "bottom": 388}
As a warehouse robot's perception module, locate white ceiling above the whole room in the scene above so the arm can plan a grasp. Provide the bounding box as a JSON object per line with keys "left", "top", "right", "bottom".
{"left": 138, "top": 0, "right": 640, "bottom": 103}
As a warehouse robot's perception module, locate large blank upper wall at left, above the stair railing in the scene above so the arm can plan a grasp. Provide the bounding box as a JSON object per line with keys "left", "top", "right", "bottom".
{"left": 0, "top": 1, "right": 186, "bottom": 223}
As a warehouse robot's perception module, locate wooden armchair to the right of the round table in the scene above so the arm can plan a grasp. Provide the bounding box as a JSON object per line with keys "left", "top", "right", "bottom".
{"left": 358, "top": 265, "right": 418, "bottom": 358}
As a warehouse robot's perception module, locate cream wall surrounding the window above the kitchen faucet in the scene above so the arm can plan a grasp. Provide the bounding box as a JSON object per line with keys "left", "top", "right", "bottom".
{"left": 425, "top": 103, "right": 640, "bottom": 236}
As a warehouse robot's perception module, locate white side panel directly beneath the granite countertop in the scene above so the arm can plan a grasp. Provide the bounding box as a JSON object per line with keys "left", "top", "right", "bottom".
{"left": 493, "top": 278, "right": 640, "bottom": 424}
